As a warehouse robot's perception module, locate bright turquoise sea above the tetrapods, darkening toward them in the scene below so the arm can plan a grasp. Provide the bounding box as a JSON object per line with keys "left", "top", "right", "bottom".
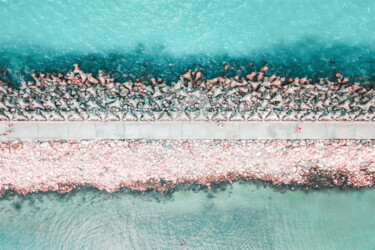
{"left": 0, "top": 0, "right": 375, "bottom": 81}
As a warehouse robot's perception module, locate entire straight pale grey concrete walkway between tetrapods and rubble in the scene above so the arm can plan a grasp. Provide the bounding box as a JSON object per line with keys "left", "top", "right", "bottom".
{"left": 0, "top": 121, "right": 375, "bottom": 140}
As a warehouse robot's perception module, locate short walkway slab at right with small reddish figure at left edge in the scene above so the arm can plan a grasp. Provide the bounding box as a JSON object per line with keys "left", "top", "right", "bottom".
{"left": 297, "top": 122, "right": 327, "bottom": 139}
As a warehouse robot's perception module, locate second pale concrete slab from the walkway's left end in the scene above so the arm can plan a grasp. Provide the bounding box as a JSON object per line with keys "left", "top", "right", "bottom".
{"left": 37, "top": 123, "right": 69, "bottom": 140}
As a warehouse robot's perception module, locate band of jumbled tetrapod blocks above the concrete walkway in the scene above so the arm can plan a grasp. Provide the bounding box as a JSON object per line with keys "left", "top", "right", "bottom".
{"left": 0, "top": 65, "right": 375, "bottom": 121}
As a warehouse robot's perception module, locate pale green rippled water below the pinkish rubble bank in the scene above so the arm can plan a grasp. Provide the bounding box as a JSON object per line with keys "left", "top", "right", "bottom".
{"left": 0, "top": 184, "right": 375, "bottom": 249}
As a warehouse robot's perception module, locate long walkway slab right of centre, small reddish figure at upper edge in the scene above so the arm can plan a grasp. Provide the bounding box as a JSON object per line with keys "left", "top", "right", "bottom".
{"left": 182, "top": 122, "right": 240, "bottom": 139}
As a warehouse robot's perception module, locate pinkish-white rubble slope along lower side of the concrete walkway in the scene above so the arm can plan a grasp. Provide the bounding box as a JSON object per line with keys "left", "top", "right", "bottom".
{"left": 0, "top": 140, "right": 375, "bottom": 194}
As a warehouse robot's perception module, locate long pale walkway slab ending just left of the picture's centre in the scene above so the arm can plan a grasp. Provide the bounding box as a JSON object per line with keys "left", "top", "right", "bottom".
{"left": 125, "top": 122, "right": 182, "bottom": 139}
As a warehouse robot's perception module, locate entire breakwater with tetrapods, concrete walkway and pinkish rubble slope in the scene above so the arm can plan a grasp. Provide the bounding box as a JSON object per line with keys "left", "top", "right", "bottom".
{"left": 0, "top": 65, "right": 375, "bottom": 194}
